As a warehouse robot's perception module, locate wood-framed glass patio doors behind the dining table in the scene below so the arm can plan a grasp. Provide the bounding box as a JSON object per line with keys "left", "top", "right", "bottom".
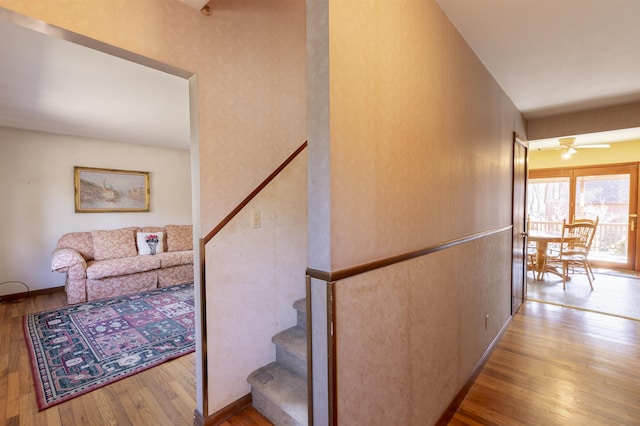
{"left": 527, "top": 164, "right": 639, "bottom": 271}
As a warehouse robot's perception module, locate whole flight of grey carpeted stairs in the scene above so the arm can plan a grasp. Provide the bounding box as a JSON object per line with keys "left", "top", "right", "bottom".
{"left": 247, "top": 299, "right": 308, "bottom": 426}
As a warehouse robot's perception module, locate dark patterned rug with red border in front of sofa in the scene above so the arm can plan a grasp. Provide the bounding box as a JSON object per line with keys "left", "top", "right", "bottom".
{"left": 24, "top": 284, "right": 195, "bottom": 411}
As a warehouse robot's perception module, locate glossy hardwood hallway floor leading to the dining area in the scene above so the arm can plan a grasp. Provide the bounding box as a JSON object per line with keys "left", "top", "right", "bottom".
{"left": 449, "top": 301, "right": 640, "bottom": 425}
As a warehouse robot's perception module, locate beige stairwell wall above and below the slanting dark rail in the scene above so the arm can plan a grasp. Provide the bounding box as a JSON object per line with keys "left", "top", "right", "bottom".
{"left": 198, "top": 0, "right": 308, "bottom": 412}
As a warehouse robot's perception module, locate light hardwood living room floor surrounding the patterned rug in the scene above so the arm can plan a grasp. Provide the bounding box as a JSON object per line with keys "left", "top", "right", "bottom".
{"left": 0, "top": 292, "right": 196, "bottom": 426}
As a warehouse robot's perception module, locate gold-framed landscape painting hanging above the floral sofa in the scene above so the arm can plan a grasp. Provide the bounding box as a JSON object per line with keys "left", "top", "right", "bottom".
{"left": 73, "top": 166, "right": 149, "bottom": 213}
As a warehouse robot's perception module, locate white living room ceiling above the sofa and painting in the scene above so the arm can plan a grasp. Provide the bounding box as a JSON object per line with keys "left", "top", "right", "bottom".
{"left": 0, "top": 14, "right": 190, "bottom": 149}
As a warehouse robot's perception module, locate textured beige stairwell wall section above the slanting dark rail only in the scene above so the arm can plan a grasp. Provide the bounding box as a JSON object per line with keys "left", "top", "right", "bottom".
{"left": 198, "top": 0, "right": 306, "bottom": 233}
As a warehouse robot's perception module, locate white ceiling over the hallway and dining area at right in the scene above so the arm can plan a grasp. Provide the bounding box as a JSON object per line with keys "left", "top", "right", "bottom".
{"left": 436, "top": 0, "right": 640, "bottom": 147}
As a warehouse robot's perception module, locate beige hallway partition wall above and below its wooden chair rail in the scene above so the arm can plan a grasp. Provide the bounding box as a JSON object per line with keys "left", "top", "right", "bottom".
{"left": 307, "top": 0, "right": 525, "bottom": 424}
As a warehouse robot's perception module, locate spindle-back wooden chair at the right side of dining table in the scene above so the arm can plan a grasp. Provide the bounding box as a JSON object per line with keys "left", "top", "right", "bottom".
{"left": 547, "top": 218, "right": 598, "bottom": 290}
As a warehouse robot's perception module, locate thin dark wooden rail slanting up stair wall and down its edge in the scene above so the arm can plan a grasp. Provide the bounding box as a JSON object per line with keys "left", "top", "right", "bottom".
{"left": 200, "top": 141, "right": 307, "bottom": 417}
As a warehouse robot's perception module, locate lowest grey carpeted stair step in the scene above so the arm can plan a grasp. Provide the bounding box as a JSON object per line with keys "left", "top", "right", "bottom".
{"left": 247, "top": 362, "right": 308, "bottom": 426}
